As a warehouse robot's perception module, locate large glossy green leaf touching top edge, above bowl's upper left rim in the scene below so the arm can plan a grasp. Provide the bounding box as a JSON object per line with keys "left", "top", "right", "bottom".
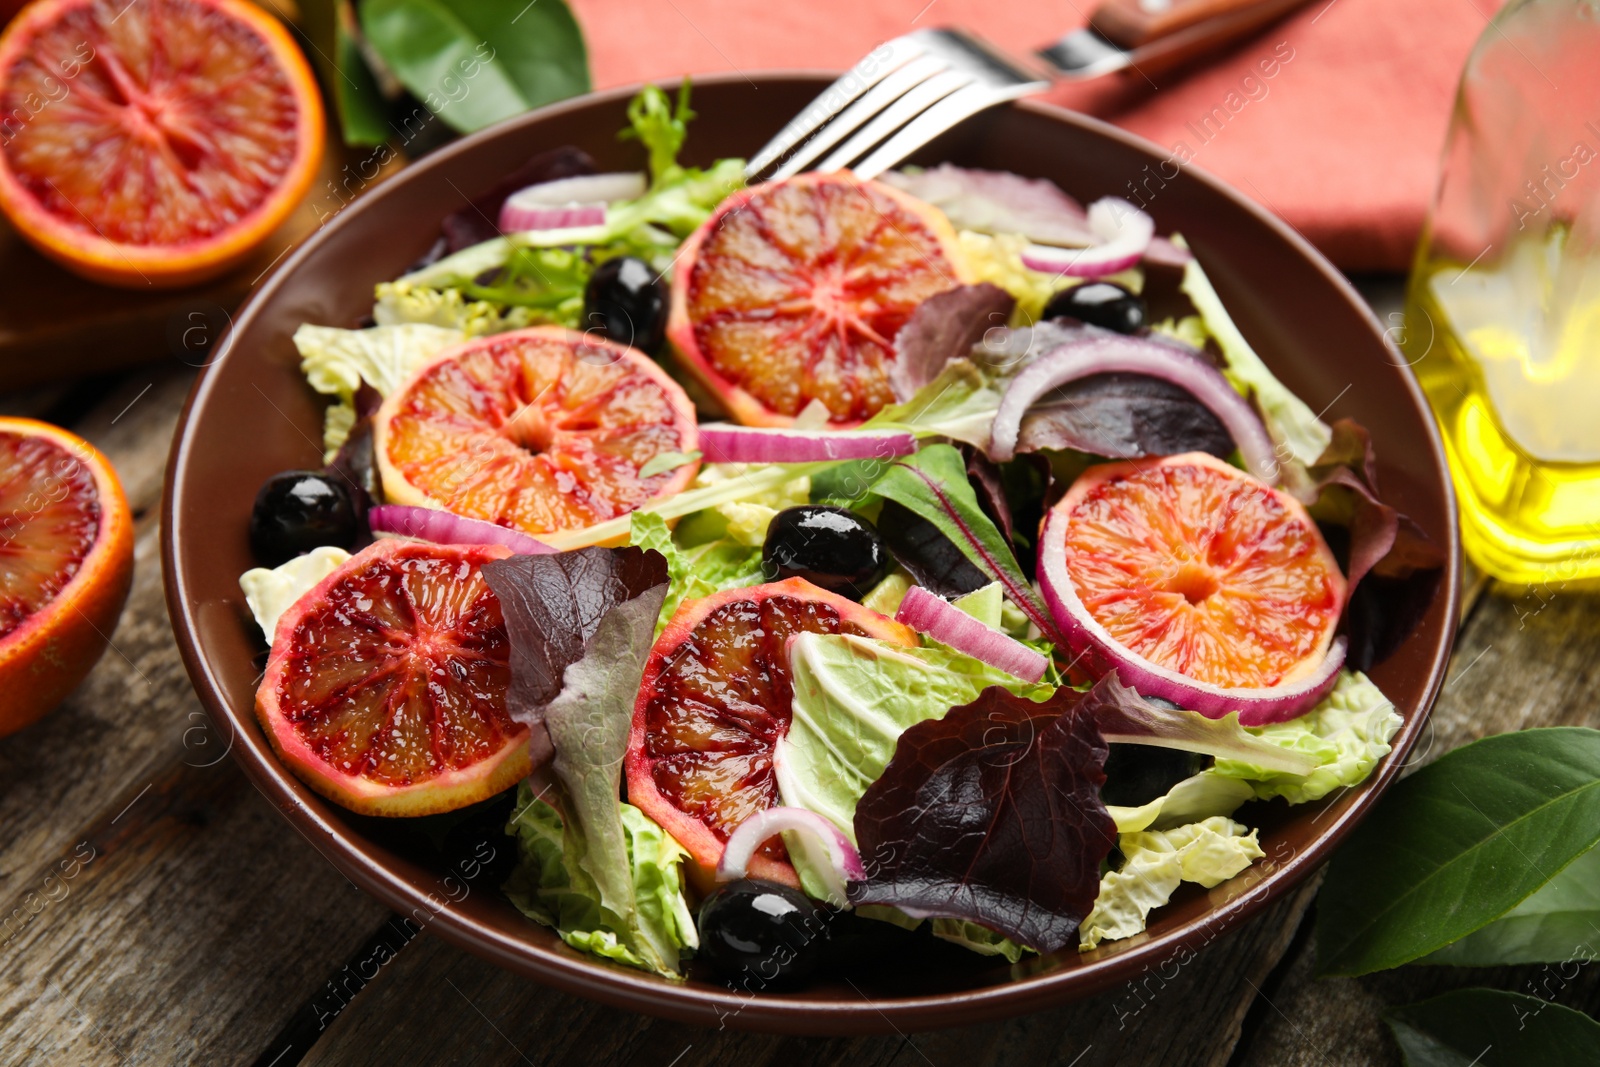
{"left": 360, "top": 0, "right": 589, "bottom": 133}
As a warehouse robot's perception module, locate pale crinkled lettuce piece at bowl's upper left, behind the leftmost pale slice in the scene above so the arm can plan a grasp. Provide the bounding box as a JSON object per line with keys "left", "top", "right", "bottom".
{"left": 294, "top": 316, "right": 466, "bottom": 451}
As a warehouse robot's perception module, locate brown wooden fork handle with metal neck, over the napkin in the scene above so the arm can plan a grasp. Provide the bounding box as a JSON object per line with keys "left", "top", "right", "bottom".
{"left": 1038, "top": 0, "right": 1309, "bottom": 80}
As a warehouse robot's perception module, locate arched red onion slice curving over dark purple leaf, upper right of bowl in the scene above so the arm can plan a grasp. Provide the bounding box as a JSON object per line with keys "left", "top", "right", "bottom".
{"left": 989, "top": 334, "right": 1280, "bottom": 485}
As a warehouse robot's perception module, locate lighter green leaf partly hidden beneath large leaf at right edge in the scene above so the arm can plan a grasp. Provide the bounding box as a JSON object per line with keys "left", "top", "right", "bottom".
{"left": 1418, "top": 848, "right": 1600, "bottom": 966}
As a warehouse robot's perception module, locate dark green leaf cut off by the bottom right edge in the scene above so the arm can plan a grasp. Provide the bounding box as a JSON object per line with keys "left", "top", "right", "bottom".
{"left": 1384, "top": 989, "right": 1600, "bottom": 1067}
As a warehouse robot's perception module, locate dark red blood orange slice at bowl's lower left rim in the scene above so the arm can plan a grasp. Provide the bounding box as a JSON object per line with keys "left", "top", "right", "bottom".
{"left": 256, "top": 541, "right": 533, "bottom": 816}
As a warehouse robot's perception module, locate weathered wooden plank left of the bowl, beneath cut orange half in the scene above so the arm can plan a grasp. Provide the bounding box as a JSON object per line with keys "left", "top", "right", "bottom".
{"left": 0, "top": 370, "right": 382, "bottom": 1064}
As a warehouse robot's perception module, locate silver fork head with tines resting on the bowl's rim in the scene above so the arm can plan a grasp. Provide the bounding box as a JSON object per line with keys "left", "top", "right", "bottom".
{"left": 744, "top": 29, "right": 1050, "bottom": 181}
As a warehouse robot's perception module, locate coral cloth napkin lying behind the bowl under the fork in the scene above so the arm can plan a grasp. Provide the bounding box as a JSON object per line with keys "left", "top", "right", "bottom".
{"left": 573, "top": 0, "right": 1499, "bottom": 270}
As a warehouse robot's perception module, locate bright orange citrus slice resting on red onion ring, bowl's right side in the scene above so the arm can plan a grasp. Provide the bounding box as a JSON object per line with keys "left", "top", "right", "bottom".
{"left": 1040, "top": 453, "right": 1344, "bottom": 689}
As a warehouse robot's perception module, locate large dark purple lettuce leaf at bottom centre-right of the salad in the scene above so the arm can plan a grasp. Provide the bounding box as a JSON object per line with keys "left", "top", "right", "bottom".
{"left": 850, "top": 686, "right": 1117, "bottom": 952}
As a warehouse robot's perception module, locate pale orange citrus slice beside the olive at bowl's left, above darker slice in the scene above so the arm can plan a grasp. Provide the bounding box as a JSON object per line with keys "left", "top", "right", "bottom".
{"left": 373, "top": 326, "right": 699, "bottom": 534}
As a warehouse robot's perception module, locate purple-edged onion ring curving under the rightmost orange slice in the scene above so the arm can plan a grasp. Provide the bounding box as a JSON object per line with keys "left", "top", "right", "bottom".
{"left": 1038, "top": 510, "right": 1346, "bottom": 726}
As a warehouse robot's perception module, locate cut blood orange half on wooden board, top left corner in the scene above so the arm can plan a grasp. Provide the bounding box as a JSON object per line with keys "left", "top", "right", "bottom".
{"left": 0, "top": 0, "right": 323, "bottom": 286}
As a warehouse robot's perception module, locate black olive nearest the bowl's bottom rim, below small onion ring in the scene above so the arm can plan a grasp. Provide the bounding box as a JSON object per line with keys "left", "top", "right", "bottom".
{"left": 699, "top": 878, "right": 832, "bottom": 990}
